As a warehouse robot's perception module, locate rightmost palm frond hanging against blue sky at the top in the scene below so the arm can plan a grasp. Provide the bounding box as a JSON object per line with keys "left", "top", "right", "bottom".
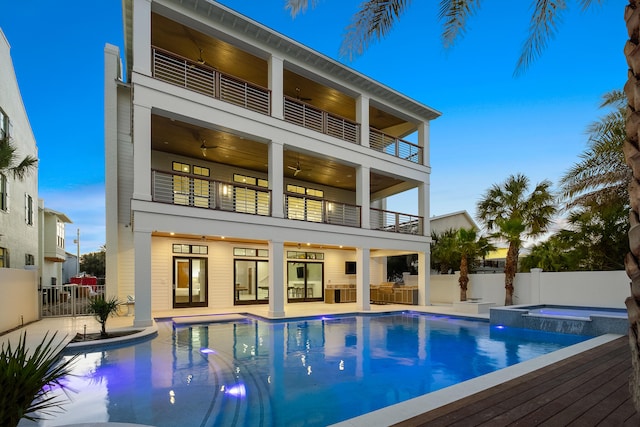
{"left": 514, "top": 0, "right": 567, "bottom": 76}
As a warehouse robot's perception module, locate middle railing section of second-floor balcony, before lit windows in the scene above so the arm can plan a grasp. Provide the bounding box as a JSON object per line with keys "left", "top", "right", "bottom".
{"left": 284, "top": 193, "right": 361, "bottom": 227}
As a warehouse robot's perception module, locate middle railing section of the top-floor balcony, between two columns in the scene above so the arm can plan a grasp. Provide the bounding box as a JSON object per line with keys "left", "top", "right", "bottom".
{"left": 284, "top": 96, "right": 360, "bottom": 144}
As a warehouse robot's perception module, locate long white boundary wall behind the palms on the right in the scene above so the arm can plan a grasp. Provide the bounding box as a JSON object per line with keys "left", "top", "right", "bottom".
{"left": 430, "top": 269, "right": 629, "bottom": 308}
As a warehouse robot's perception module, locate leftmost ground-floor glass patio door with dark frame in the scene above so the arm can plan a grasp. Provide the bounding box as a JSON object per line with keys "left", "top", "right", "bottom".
{"left": 173, "top": 258, "right": 208, "bottom": 308}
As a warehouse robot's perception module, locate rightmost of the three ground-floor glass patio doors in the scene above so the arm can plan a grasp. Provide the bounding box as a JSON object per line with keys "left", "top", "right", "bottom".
{"left": 287, "top": 261, "right": 324, "bottom": 302}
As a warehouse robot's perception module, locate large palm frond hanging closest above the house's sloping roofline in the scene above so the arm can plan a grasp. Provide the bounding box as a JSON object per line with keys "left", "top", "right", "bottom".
{"left": 340, "top": 0, "right": 409, "bottom": 60}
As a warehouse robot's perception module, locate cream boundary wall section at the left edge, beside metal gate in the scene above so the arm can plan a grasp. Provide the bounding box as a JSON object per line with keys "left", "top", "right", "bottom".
{"left": 0, "top": 268, "right": 39, "bottom": 332}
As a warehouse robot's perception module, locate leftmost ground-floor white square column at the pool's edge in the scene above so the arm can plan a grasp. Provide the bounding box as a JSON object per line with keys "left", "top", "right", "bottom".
{"left": 133, "top": 230, "right": 153, "bottom": 327}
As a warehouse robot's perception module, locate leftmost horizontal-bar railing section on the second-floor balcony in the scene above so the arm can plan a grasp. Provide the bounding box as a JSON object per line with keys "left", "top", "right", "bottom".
{"left": 151, "top": 170, "right": 271, "bottom": 216}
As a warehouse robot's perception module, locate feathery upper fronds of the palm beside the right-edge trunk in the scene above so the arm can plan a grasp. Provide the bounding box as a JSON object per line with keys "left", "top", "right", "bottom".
{"left": 560, "top": 90, "right": 631, "bottom": 209}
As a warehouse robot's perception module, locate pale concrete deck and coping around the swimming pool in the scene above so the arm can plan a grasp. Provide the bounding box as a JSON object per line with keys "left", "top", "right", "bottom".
{"left": 0, "top": 303, "right": 636, "bottom": 427}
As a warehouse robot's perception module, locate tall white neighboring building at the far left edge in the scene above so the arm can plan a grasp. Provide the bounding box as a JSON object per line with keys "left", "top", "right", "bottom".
{"left": 0, "top": 29, "right": 38, "bottom": 269}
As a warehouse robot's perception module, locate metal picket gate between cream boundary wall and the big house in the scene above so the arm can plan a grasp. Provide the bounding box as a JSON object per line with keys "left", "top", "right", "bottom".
{"left": 40, "top": 284, "right": 105, "bottom": 317}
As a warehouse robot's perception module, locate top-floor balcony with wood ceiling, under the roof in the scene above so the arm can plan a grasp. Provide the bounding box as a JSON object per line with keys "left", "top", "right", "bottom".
{"left": 150, "top": 13, "right": 425, "bottom": 165}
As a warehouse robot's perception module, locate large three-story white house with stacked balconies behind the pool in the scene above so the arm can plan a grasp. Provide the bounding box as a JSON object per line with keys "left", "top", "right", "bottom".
{"left": 105, "top": 0, "right": 440, "bottom": 326}
